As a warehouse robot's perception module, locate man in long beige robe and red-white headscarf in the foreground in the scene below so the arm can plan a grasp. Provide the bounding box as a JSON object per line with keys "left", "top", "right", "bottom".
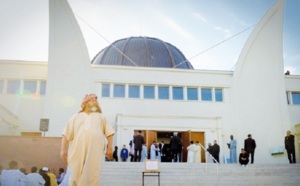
{"left": 60, "top": 94, "right": 114, "bottom": 186}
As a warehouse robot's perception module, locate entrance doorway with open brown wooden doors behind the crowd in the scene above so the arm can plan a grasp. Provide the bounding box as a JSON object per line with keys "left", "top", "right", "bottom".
{"left": 134, "top": 130, "right": 206, "bottom": 162}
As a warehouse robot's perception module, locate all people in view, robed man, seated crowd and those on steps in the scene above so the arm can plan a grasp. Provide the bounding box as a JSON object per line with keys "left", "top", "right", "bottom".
{"left": 0, "top": 94, "right": 296, "bottom": 186}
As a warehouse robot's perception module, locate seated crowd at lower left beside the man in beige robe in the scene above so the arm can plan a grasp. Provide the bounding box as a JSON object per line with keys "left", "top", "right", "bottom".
{"left": 0, "top": 160, "right": 65, "bottom": 186}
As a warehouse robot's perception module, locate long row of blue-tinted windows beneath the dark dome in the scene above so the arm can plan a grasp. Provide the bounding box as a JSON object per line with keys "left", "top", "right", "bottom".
{"left": 97, "top": 80, "right": 224, "bottom": 104}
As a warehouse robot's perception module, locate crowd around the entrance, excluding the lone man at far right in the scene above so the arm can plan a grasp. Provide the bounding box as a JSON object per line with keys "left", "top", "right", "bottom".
{"left": 113, "top": 131, "right": 256, "bottom": 165}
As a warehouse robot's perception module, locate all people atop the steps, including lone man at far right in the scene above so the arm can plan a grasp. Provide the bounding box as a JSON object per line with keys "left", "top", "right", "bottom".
{"left": 120, "top": 131, "right": 296, "bottom": 166}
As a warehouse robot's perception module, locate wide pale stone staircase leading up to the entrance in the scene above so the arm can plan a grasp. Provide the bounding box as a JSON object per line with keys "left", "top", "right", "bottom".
{"left": 101, "top": 162, "right": 300, "bottom": 186}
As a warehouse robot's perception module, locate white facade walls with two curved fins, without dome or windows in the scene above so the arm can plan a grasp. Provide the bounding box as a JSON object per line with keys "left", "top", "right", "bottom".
{"left": 0, "top": 0, "right": 300, "bottom": 163}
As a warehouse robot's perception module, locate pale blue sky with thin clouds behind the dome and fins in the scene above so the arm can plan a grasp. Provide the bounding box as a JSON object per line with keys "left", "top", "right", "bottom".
{"left": 0, "top": 0, "right": 300, "bottom": 75}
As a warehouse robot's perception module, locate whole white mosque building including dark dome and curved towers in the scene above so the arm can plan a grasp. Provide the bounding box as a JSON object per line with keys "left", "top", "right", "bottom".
{"left": 0, "top": 0, "right": 300, "bottom": 163}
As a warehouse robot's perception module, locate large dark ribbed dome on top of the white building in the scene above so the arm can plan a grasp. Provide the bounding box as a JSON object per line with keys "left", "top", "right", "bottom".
{"left": 92, "top": 37, "right": 194, "bottom": 69}
